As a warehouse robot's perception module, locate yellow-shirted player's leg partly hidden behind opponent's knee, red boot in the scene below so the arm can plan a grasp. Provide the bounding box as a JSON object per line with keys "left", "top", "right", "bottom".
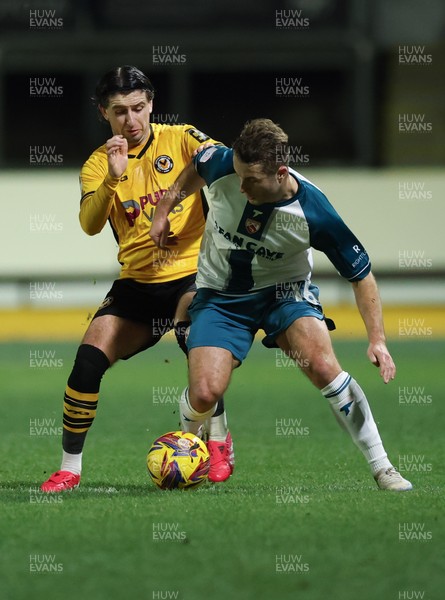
{"left": 175, "top": 292, "right": 235, "bottom": 482}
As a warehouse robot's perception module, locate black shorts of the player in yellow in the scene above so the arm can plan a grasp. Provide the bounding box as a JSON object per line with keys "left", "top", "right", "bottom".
{"left": 93, "top": 274, "right": 196, "bottom": 352}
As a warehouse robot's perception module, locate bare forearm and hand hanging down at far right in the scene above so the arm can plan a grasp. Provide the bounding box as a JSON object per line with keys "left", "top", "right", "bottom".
{"left": 352, "top": 273, "right": 396, "bottom": 383}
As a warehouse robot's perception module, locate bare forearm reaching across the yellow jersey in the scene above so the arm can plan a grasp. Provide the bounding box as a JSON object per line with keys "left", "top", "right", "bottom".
{"left": 149, "top": 163, "right": 206, "bottom": 249}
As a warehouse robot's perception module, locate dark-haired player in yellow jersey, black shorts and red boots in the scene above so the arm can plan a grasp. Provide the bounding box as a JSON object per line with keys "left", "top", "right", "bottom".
{"left": 41, "top": 66, "right": 233, "bottom": 492}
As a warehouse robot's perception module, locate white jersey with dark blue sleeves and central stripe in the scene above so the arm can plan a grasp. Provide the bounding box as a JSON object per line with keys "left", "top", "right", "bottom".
{"left": 194, "top": 146, "right": 371, "bottom": 301}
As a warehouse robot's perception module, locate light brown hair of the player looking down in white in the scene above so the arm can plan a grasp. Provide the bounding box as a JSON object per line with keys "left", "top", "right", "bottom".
{"left": 233, "top": 119, "right": 289, "bottom": 173}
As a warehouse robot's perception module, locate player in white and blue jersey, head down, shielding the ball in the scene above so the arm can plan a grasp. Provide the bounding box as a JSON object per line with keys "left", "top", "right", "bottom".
{"left": 150, "top": 119, "right": 412, "bottom": 491}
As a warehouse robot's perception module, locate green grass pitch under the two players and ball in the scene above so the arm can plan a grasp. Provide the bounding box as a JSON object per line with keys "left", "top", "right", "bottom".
{"left": 0, "top": 339, "right": 445, "bottom": 600}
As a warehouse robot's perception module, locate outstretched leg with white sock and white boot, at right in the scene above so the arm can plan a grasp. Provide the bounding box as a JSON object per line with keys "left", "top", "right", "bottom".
{"left": 277, "top": 317, "right": 412, "bottom": 491}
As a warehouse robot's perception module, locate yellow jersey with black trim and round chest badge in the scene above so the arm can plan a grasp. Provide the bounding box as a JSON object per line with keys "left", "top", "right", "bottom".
{"left": 80, "top": 123, "right": 218, "bottom": 283}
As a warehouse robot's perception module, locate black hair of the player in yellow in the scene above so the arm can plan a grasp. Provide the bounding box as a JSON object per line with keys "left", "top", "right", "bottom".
{"left": 94, "top": 65, "right": 155, "bottom": 108}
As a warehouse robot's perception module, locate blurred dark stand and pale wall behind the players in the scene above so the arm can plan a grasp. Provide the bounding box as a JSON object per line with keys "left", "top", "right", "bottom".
{"left": 0, "top": 0, "right": 445, "bottom": 341}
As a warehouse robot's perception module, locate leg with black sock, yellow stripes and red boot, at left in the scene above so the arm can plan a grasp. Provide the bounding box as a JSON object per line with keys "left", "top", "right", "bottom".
{"left": 41, "top": 315, "right": 152, "bottom": 492}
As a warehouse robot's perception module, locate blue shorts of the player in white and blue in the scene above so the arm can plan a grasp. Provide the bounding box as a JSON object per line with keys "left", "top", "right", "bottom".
{"left": 187, "top": 284, "right": 324, "bottom": 362}
